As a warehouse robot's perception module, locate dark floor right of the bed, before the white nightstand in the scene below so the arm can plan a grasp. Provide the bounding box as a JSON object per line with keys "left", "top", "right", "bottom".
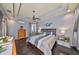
{"left": 52, "top": 44, "right": 79, "bottom": 55}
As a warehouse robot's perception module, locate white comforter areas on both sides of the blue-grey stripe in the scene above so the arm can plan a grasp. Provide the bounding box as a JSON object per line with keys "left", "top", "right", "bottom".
{"left": 29, "top": 34, "right": 56, "bottom": 55}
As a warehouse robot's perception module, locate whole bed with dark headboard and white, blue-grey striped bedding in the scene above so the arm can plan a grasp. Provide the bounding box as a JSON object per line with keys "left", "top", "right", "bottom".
{"left": 28, "top": 29, "right": 57, "bottom": 55}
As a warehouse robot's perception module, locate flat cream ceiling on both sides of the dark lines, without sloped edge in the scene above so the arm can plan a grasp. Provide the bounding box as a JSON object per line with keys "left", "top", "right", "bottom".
{"left": 1, "top": 3, "right": 67, "bottom": 17}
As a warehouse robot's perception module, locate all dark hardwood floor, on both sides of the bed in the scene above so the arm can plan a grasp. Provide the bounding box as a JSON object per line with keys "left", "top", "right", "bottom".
{"left": 15, "top": 40, "right": 79, "bottom": 55}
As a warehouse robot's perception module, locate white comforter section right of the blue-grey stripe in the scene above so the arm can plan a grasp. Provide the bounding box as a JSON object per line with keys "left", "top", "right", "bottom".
{"left": 37, "top": 35, "right": 56, "bottom": 55}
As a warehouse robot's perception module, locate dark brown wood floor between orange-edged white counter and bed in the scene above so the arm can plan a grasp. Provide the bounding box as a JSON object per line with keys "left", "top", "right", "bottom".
{"left": 15, "top": 40, "right": 43, "bottom": 55}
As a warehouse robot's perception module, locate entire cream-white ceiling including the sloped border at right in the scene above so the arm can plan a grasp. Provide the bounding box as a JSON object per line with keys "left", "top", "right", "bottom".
{"left": 0, "top": 3, "right": 78, "bottom": 19}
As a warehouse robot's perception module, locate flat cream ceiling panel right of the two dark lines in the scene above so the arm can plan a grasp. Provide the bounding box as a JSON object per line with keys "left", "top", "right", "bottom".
{"left": 19, "top": 3, "right": 62, "bottom": 17}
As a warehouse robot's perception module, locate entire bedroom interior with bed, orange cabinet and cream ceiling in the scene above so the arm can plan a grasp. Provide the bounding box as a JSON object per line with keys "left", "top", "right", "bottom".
{"left": 0, "top": 3, "right": 79, "bottom": 55}
